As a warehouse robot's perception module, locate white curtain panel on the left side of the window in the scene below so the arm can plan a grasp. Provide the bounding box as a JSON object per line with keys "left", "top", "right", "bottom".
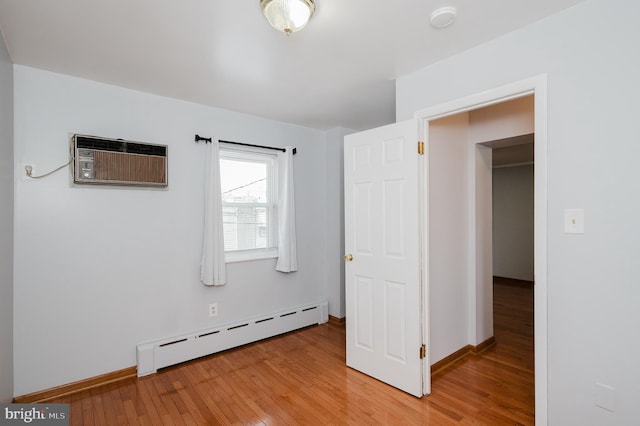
{"left": 200, "top": 138, "right": 227, "bottom": 285}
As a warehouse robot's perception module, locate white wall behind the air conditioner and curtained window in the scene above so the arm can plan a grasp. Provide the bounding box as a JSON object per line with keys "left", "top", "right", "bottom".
{"left": 12, "top": 66, "right": 327, "bottom": 396}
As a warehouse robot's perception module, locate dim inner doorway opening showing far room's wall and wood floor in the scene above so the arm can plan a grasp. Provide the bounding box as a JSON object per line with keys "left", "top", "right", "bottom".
{"left": 483, "top": 132, "right": 535, "bottom": 390}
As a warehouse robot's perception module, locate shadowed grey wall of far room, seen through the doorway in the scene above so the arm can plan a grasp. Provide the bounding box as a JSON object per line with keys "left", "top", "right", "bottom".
{"left": 493, "top": 164, "right": 533, "bottom": 281}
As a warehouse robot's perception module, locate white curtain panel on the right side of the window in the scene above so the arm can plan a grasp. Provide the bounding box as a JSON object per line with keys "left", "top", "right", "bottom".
{"left": 276, "top": 146, "right": 298, "bottom": 272}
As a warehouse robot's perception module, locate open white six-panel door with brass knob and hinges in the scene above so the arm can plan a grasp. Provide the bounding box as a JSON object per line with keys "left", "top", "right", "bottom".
{"left": 344, "top": 120, "right": 430, "bottom": 397}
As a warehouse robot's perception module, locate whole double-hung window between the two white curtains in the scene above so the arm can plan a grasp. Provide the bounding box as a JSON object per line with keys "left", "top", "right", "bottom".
{"left": 220, "top": 147, "right": 278, "bottom": 262}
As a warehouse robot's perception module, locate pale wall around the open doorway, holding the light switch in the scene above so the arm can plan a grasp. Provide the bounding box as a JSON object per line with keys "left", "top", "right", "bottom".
{"left": 396, "top": 0, "right": 640, "bottom": 425}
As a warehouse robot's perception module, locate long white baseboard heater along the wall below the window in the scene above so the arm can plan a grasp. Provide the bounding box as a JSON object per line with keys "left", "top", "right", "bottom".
{"left": 136, "top": 301, "right": 329, "bottom": 377}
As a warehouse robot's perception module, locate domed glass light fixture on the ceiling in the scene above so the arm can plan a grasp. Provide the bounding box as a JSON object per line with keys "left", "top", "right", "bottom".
{"left": 260, "top": 0, "right": 316, "bottom": 35}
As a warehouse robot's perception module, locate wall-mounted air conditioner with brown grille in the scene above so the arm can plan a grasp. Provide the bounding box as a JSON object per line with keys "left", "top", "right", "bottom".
{"left": 71, "top": 135, "right": 167, "bottom": 187}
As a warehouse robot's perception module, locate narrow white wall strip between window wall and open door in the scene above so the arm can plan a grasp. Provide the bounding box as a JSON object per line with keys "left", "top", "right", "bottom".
{"left": 320, "top": 127, "right": 354, "bottom": 318}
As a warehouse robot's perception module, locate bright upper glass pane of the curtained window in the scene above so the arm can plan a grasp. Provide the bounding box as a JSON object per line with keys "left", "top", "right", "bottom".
{"left": 220, "top": 159, "right": 269, "bottom": 203}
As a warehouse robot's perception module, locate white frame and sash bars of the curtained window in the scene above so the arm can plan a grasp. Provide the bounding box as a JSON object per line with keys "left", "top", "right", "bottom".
{"left": 219, "top": 144, "right": 279, "bottom": 263}
